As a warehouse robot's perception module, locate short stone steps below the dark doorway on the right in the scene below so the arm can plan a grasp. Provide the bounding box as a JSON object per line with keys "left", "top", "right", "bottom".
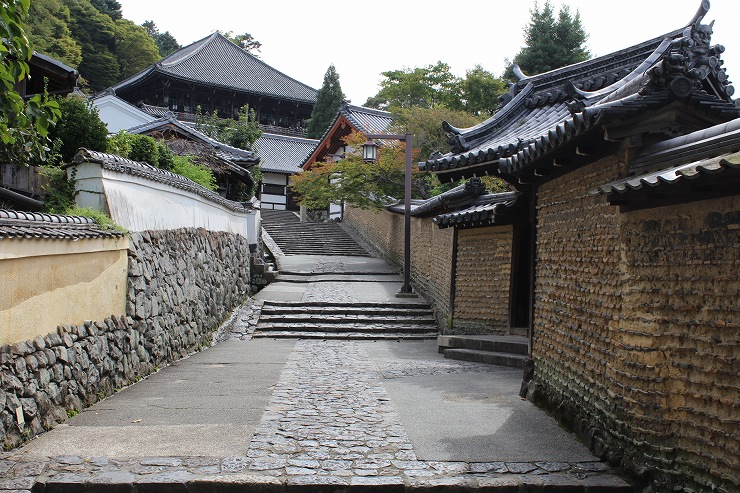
{"left": 437, "top": 335, "right": 528, "bottom": 368}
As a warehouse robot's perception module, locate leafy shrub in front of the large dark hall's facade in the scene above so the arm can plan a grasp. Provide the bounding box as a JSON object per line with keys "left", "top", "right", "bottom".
{"left": 195, "top": 105, "right": 262, "bottom": 150}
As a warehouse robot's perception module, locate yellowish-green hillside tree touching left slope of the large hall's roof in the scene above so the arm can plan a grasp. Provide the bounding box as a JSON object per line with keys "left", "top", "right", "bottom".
{"left": 115, "top": 19, "right": 159, "bottom": 78}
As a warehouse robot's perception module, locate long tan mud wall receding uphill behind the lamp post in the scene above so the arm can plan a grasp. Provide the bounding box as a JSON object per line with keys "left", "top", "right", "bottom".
{"left": 344, "top": 207, "right": 454, "bottom": 329}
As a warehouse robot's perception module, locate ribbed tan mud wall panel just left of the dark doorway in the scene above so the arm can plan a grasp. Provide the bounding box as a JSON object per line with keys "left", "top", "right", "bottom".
{"left": 451, "top": 226, "right": 513, "bottom": 334}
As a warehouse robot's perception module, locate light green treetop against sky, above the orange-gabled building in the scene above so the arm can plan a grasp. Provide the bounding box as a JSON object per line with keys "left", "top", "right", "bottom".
{"left": 365, "top": 61, "right": 459, "bottom": 109}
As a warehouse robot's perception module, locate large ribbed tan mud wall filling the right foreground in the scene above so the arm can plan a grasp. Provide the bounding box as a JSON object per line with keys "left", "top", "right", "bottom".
{"left": 530, "top": 156, "right": 740, "bottom": 492}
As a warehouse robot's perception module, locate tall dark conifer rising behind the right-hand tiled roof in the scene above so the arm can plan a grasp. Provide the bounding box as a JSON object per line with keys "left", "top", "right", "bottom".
{"left": 505, "top": 0, "right": 591, "bottom": 78}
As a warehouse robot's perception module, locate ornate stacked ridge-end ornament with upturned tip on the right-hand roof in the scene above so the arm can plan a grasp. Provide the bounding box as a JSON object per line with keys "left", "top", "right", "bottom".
{"left": 640, "top": 0, "right": 735, "bottom": 101}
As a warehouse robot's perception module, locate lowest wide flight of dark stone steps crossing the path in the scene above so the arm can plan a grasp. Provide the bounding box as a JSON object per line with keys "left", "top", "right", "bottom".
{"left": 253, "top": 301, "right": 437, "bottom": 340}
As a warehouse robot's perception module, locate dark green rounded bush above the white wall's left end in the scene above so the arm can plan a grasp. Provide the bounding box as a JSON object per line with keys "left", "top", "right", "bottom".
{"left": 49, "top": 96, "right": 108, "bottom": 163}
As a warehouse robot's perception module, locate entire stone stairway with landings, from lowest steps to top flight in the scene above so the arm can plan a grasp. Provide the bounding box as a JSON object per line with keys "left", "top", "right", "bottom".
{"left": 252, "top": 211, "right": 437, "bottom": 340}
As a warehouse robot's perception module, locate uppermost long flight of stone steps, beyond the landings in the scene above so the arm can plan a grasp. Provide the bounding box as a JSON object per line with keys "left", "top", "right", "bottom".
{"left": 261, "top": 210, "right": 370, "bottom": 257}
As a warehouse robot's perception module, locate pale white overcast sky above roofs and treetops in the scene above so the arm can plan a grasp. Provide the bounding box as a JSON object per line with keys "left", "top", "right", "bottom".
{"left": 119, "top": 0, "right": 740, "bottom": 105}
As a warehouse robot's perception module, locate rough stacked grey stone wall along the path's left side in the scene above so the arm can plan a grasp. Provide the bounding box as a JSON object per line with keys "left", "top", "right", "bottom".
{"left": 0, "top": 229, "right": 250, "bottom": 448}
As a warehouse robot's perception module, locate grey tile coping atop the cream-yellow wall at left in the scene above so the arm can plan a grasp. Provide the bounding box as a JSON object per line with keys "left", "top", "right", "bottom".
{"left": 0, "top": 209, "right": 124, "bottom": 240}
